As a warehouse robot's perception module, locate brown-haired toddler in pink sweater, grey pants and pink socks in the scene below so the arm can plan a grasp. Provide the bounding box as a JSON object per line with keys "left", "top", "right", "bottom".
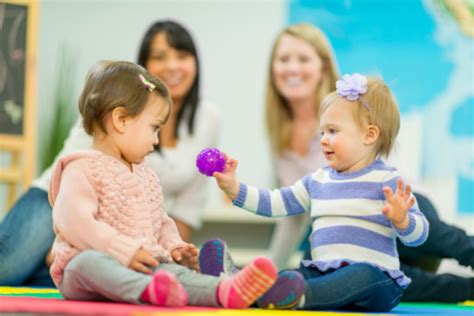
{"left": 49, "top": 62, "right": 276, "bottom": 308}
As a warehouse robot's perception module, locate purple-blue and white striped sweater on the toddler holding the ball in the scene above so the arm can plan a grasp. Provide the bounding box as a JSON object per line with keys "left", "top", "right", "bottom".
{"left": 234, "top": 159, "right": 428, "bottom": 287}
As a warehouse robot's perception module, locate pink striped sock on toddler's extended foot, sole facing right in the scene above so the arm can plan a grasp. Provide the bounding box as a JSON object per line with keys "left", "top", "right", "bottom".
{"left": 217, "top": 257, "right": 277, "bottom": 308}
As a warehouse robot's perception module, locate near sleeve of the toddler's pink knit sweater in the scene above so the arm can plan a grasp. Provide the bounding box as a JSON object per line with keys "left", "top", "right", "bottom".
{"left": 53, "top": 160, "right": 141, "bottom": 266}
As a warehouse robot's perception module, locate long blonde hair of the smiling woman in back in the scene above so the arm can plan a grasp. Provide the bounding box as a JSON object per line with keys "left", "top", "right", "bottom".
{"left": 265, "top": 23, "right": 339, "bottom": 154}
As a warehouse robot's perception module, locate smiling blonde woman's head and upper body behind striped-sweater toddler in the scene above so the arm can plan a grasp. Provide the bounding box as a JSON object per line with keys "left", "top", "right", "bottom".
{"left": 265, "top": 24, "right": 339, "bottom": 268}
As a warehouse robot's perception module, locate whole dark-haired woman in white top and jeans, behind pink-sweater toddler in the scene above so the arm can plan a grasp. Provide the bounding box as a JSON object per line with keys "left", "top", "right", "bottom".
{"left": 0, "top": 21, "right": 219, "bottom": 286}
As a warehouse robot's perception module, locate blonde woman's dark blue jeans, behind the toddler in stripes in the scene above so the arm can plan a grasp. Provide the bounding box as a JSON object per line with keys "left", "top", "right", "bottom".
{"left": 303, "top": 193, "right": 474, "bottom": 303}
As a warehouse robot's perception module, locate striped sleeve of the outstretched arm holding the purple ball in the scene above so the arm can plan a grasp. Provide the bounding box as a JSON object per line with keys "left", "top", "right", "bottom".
{"left": 233, "top": 178, "right": 311, "bottom": 217}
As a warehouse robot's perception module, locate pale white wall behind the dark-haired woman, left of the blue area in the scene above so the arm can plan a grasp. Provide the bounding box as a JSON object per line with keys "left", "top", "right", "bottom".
{"left": 38, "top": 0, "right": 284, "bottom": 185}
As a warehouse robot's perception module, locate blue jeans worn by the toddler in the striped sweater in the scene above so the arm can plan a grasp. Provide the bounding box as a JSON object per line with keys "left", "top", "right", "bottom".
{"left": 296, "top": 263, "right": 403, "bottom": 312}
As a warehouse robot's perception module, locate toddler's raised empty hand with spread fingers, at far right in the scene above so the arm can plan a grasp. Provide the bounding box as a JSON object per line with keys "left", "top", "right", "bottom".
{"left": 382, "top": 179, "right": 415, "bottom": 230}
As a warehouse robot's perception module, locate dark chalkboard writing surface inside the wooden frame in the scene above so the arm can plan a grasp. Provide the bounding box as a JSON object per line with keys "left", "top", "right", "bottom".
{"left": 0, "top": 3, "right": 28, "bottom": 135}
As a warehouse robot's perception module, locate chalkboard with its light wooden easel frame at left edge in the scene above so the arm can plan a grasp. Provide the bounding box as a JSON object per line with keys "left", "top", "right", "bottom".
{"left": 0, "top": 0, "right": 39, "bottom": 209}
